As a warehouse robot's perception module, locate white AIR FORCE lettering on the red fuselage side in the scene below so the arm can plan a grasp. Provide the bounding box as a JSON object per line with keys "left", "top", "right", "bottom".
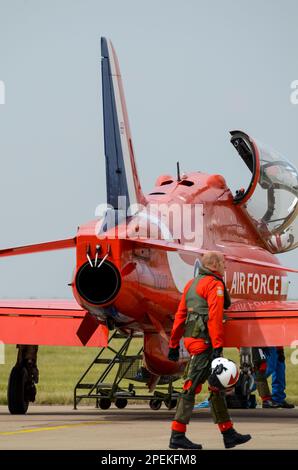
{"left": 230, "top": 271, "right": 287, "bottom": 295}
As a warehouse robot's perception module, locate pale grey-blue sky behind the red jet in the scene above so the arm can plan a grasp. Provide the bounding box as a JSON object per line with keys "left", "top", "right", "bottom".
{"left": 0, "top": 0, "right": 298, "bottom": 298}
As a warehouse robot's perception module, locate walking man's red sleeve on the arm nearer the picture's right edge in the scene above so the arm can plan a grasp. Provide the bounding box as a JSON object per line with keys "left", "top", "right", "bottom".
{"left": 206, "top": 280, "right": 224, "bottom": 348}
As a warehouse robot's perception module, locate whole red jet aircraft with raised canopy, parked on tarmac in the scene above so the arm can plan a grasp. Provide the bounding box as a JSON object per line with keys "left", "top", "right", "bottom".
{"left": 0, "top": 38, "right": 298, "bottom": 412}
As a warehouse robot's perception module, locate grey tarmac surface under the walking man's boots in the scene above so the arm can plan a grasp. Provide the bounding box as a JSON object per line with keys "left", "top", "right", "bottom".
{"left": 0, "top": 404, "right": 298, "bottom": 450}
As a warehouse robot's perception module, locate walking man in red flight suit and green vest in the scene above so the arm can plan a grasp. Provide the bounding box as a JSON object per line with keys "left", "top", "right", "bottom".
{"left": 168, "top": 252, "right": 251, "bottom": 449}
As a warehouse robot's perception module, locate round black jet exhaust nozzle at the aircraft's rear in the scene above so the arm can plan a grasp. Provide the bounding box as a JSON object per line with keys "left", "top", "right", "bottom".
{"left": 75, "top": 258, "right": 121, "bottom": 305}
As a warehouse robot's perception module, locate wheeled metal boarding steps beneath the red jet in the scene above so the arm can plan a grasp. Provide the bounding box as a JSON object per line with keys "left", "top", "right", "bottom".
{"left": 74, "top": 330, "right": 179, "bottom": 410}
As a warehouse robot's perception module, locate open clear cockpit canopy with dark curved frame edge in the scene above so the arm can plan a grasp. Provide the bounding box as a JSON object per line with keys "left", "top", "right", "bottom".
{"left": 231, "top": 131, "right": 298, "bottom": 253}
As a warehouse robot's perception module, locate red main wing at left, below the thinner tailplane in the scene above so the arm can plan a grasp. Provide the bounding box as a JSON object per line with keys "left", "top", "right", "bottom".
{"left": 0, "top": 299, "right": 108, "bottom": 347}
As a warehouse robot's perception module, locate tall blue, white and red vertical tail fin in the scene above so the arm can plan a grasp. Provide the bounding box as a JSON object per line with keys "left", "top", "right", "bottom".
{"left": 101, "top": 38, "right": 145, "bottom": 209}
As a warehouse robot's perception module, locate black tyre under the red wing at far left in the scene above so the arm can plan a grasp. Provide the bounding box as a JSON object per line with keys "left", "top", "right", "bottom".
{"left": 7, "top": 366, "right": 29, "bottom": 415}
